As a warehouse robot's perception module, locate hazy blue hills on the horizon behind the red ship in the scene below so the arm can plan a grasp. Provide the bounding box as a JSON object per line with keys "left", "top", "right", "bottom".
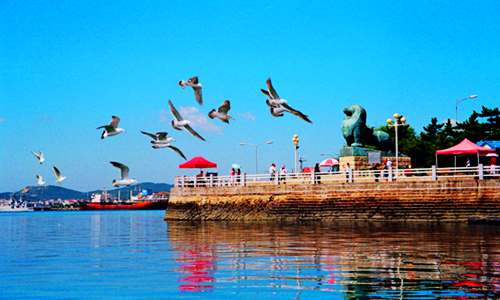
{"left": 0, "top": 182, "right": 172, "bottom": 201}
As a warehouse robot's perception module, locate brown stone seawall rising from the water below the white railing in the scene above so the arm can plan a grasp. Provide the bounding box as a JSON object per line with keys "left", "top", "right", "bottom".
{"left": 165, "top": 178, "right": 500, "bottom": 222}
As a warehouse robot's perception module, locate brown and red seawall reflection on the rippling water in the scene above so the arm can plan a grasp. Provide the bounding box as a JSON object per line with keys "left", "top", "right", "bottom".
{"left": 168, "top": 222, "right": 500, "bottom": 299}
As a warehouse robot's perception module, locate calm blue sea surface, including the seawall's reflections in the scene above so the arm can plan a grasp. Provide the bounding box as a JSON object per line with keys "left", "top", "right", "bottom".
{"left": 0, "top": 211, "right": 500, "bottom": 299}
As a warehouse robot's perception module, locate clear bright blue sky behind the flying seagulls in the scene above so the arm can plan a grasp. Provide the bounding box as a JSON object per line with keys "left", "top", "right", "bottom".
{"left": 0, "top": 0, "right": 500, "bottom": 191}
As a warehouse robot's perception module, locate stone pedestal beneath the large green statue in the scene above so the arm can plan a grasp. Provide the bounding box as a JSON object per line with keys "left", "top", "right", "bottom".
{"left": 339, "top": 146, "right": 411, "bottom": 170}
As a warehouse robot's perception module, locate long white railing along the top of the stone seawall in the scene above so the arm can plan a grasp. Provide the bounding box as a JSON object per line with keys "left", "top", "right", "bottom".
{"left": 174, "top": 165, "right": 500, "bottom": 188}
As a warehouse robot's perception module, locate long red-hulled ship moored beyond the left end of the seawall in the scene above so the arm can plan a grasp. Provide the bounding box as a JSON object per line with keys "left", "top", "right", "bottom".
{"left": 81, "top": 193, "right": 168, "bottom": 210}
